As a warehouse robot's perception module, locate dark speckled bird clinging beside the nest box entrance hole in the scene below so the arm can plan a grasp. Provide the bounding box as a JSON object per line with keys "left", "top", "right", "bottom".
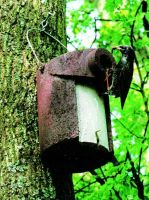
{"left": 109, "top": 45, "right": 135, "bottom": 109}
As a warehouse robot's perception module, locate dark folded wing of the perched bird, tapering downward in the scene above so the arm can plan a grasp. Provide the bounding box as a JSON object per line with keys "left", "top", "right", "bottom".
{"left": 120, "top": 69, "right": 133, "bottom": 109}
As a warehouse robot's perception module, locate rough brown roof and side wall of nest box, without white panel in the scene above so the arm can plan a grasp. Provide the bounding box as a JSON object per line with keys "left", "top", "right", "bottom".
{"left": 37, "top": 49, "right": 115, "bottom": 152}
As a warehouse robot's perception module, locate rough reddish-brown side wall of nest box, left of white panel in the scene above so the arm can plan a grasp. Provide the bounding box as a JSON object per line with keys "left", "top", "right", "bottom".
{"left": 37, "top": 72, "right": 78, "bottom": 151}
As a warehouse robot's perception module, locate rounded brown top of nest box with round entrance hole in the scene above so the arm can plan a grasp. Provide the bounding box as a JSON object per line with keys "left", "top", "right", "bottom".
{"left": 45, "top": 49, "right": 115, "bottom": 77}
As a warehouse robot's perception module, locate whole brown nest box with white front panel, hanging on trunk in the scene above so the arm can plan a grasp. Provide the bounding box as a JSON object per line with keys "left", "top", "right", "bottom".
{"left": 37, "top": 49, "right": 115, "bottom": 172}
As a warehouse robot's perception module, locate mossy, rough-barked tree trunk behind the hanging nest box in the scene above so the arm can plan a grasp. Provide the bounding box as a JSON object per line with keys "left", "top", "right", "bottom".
{"left": 0, "top": 0, "right": 66, "bottom": 200}
